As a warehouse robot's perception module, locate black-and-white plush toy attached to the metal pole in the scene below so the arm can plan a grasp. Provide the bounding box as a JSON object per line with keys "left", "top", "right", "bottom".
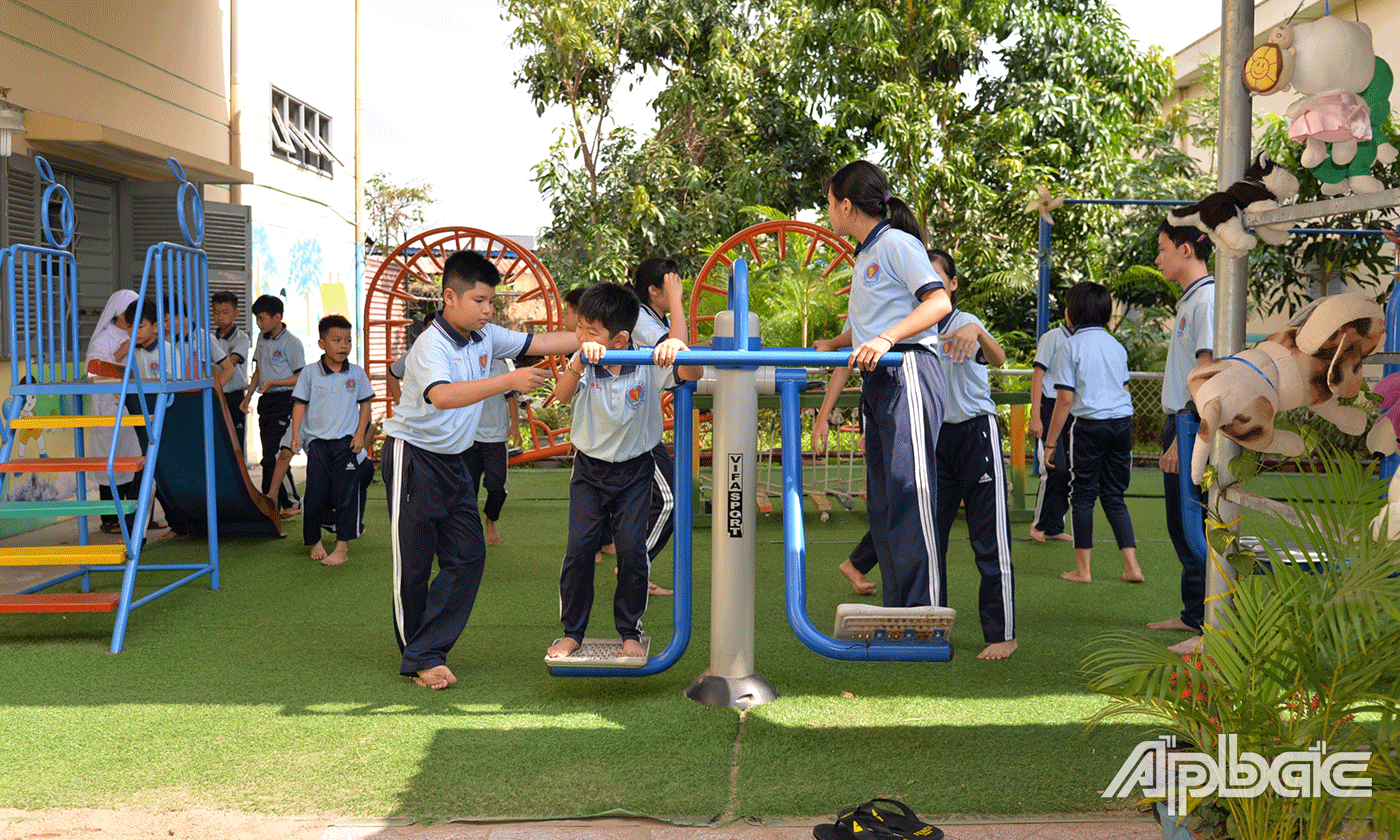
{"left": 1166, "top": 151, "right": 1298, "bottom": 256}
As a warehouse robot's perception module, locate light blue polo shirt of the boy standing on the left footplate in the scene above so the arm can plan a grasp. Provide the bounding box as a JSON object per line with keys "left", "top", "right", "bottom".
{"left": 568, "top": 342, "right": 676, "bottom": 463}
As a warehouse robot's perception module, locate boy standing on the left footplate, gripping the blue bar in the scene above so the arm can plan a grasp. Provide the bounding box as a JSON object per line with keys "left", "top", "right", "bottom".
{"left": 545, "top": 283, "right": 703, "bottom": 659}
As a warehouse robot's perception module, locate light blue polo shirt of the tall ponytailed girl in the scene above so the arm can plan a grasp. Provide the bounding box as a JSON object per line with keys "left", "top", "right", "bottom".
{"left": 847, "top": 220, "right": 944, "bottom": 353}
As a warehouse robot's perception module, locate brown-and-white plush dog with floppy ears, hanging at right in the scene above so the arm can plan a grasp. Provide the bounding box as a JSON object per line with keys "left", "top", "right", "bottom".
{"left": 1186, "top": 293, "right": 1386, "bottom": 483}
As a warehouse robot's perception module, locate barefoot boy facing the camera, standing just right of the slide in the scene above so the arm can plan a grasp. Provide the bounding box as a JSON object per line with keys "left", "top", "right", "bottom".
{"left": 290, "top": 315, "right": 374, "bottom": 566}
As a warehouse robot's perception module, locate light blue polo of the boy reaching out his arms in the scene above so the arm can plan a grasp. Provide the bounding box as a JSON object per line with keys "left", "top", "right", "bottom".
{"left": 384, "top": 315, "right": 532, "bottom": 455}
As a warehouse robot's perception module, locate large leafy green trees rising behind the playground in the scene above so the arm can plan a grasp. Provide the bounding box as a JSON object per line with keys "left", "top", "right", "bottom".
{"left": 505, "top": 0, "right": 1201, "bottom": 350}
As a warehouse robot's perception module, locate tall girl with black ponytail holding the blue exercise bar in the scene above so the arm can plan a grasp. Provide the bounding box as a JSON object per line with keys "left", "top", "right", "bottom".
{"left": 826, "top": 161, "right": 976, "bottom": 606}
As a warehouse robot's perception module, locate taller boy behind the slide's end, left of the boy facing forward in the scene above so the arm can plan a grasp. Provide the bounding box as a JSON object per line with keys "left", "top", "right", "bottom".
{"left": 239, "top": 294, "right": 307, "bottom": 515}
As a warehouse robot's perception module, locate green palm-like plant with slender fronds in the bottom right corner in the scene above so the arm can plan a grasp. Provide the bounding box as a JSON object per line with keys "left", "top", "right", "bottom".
{"left": 1084, "top": 452, "right": 1400, "bottom": 840}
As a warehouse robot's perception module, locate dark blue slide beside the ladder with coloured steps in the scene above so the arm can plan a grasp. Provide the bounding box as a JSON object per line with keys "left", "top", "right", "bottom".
{"left": 136, "top": 391, "right": 286, "bottom": 539}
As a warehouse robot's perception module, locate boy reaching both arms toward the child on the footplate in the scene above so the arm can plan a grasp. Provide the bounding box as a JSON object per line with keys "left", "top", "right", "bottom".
{"left": 382, "top": 251, "right": 578, "bottom": 689}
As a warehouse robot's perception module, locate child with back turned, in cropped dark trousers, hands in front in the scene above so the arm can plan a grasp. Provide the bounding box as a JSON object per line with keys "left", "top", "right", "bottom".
{"left": 1044, "top": 281, "right": 1142, "bottom": 584}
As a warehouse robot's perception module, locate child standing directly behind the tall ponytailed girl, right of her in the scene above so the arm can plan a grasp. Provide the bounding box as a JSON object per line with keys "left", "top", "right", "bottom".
{"left": 928, "top": 248, "right": 1016, "bottom": 659}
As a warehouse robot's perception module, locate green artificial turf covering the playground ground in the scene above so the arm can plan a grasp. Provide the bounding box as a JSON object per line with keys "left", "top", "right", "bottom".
{"left": 0, "top": 469, "right": 1282, "bottom": 820}
